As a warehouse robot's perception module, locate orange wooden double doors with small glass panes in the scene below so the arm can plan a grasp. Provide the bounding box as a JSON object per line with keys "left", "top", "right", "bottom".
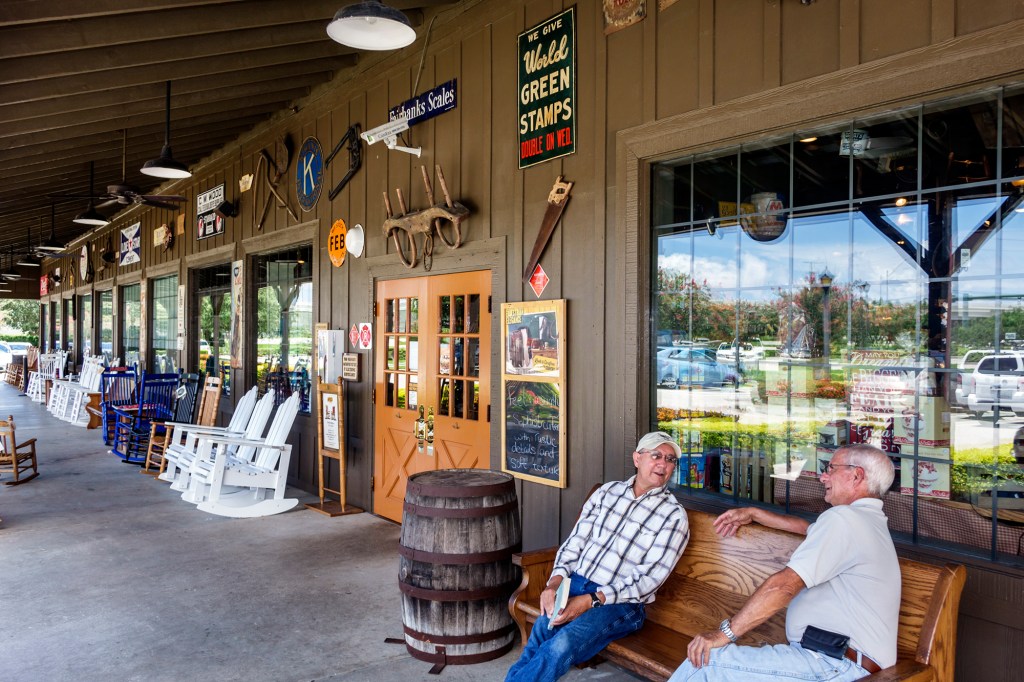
{"left": 374, "top": 270, "right": 490, "bottom": 521}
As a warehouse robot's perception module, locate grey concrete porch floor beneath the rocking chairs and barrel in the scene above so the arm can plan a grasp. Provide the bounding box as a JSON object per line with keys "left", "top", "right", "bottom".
{"left": 0, "top": 382, "right": 637, "bottom": 682}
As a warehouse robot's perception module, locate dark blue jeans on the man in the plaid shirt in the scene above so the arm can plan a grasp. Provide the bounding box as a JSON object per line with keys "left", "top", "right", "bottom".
{"left": 505, "top": 573, "right": 644, "bottom": 682}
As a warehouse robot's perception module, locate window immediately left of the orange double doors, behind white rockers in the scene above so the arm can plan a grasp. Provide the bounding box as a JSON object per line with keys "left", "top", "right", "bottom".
{"left": 254, "top": 246, "right": 313, "bottom": 412}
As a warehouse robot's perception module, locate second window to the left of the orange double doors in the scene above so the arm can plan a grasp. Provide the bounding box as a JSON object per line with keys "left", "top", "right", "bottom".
{"left": 191, "top": 263, "right": 231, "bottom": 395}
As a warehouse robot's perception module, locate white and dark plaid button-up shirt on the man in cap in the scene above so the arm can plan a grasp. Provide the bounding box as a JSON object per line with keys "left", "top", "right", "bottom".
{"left": 551, "top": 476, "right": 690, "bottom": 604}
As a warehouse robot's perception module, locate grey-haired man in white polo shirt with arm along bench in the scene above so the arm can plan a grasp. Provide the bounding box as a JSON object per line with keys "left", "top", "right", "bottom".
{"left": 670, "top": 444, "right": 901, "bottom": 682}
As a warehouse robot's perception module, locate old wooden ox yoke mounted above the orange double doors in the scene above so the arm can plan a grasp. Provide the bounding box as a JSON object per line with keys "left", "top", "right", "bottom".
{"left": 384, "top": 164, "right": 469, "bottom": 270}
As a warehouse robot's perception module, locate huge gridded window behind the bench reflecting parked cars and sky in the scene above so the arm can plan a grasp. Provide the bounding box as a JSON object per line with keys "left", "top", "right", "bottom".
{"left": 650, "top": 84, "right": 1024, "bottom": 560}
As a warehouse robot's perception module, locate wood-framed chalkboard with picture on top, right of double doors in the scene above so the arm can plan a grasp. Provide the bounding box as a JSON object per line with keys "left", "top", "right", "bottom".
{"left": 502, "top": 301, "right": 567, "bottom": 487}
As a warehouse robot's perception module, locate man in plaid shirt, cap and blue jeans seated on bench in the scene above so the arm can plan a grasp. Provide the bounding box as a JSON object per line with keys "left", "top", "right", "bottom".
{"left": 505, "top": 431, "right": 690, "bottom": 682}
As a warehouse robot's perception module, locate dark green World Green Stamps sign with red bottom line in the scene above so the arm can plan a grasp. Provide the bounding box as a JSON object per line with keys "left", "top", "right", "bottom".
{"left": 519, "top": 6, "right": 575, "bottom": 168}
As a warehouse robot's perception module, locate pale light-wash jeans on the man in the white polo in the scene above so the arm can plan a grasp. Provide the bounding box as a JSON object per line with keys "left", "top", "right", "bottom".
{"left": 669, "top": 644, "right": 867, "bottom": 682}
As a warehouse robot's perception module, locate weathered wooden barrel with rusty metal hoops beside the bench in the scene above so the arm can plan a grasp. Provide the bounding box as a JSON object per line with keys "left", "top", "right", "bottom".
{"left": 398, "top": 469, "right": 522, "bottom": 667}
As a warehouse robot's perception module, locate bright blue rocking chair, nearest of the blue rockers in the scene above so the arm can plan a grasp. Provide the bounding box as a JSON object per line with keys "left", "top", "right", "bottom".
{"left": 111, "top": 372, "right": 179, "bottom": 464}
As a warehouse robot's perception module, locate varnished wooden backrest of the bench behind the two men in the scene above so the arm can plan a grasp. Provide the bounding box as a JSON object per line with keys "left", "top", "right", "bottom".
{"left": 647, "top": 510, "right": 966, "bottom": 680}
